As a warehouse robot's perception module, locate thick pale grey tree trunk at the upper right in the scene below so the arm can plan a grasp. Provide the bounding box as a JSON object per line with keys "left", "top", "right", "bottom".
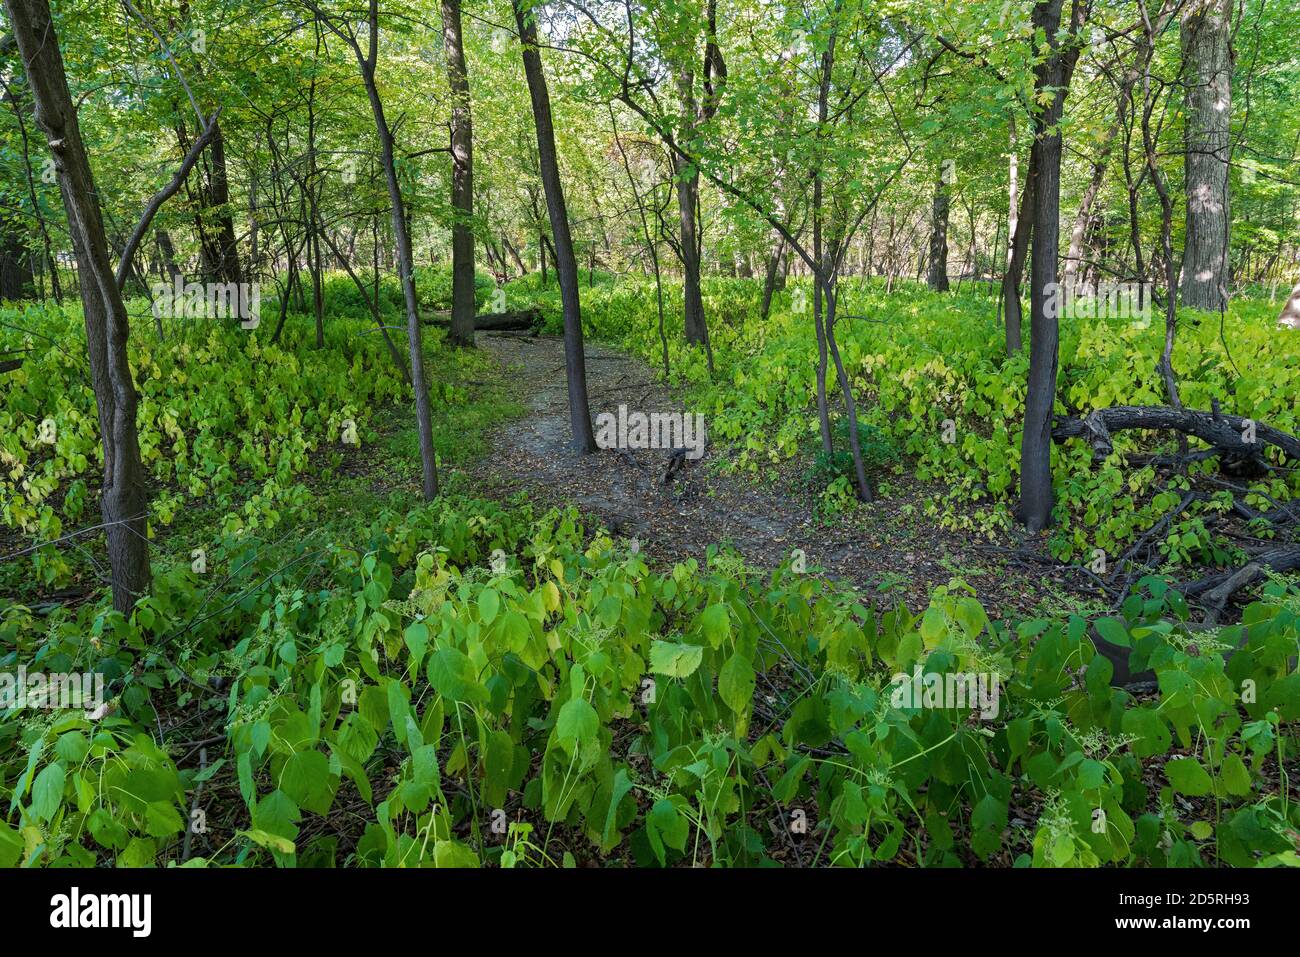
{"left": 1180, "top": 0, "right": 1232, "bottom": 309}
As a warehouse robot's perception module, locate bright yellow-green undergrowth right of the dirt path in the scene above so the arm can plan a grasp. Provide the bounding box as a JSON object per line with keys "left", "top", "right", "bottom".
{"left": 522, "top": 274, "right": 1300, "bottom": 567}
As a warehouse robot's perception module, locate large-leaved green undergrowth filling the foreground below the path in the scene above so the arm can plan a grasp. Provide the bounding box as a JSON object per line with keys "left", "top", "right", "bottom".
{"left": 0, "top": 495, "right": 1300, "bottom": 866}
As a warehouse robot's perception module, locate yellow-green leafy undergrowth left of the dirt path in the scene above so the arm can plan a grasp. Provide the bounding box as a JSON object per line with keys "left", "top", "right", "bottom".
{"left": 0, "top": 287, "right": 515, "bottom": 596}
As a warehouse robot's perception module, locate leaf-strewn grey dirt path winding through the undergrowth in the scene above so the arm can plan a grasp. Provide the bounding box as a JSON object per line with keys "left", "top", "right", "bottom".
{"left": 467, "top": 333, "right": 1054, "bottom": 614}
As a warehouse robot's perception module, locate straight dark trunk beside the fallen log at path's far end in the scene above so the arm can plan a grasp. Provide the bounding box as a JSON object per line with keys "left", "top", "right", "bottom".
{"left": 442, "top": 0, "right": 475, "bottom": 346}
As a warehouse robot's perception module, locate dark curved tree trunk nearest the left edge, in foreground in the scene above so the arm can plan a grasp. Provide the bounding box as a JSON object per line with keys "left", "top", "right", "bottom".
{"left": 5, "top": 0, "right": 151, "bottom": 614}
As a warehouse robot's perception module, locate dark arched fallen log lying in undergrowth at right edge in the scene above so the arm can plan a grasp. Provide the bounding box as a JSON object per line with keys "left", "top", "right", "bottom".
{"left": 1052, "top": 403, "right": 1300, "bottom": 462}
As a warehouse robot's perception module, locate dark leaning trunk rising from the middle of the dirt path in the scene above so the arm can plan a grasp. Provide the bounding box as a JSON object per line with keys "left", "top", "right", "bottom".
{"left": 510, "top": 0, "right": 595, "bottom": 455}
